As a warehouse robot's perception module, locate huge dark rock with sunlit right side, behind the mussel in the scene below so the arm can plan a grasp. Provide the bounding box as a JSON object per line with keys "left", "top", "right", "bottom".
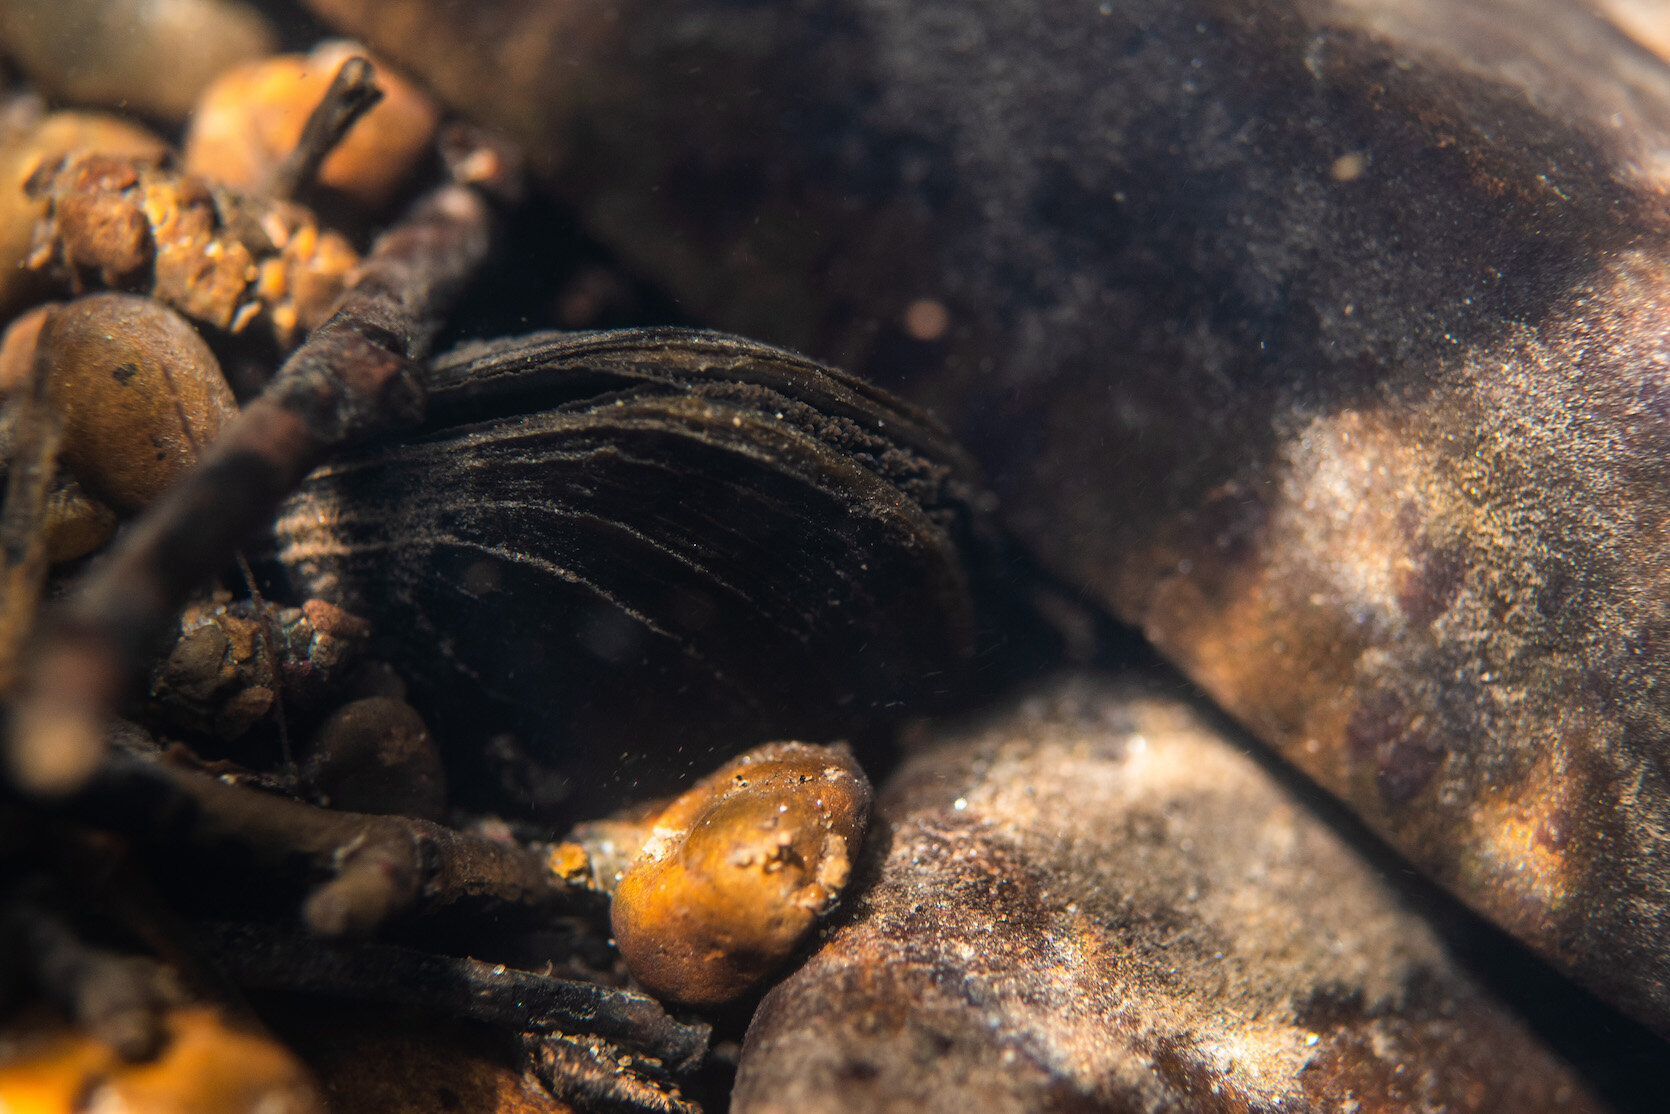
{"left": 312, "top": 0, "right": 1670, "bottom": 1032}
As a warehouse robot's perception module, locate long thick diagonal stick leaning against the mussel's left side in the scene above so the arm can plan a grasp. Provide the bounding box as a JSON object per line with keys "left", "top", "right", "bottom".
{"left": 7, "top": 178, "right": 491, "bottom": 795}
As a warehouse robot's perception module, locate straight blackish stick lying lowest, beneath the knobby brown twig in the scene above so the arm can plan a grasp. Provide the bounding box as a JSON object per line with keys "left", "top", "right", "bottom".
{"left": 202, "top": 925, "right": 710, "bottom": 1074}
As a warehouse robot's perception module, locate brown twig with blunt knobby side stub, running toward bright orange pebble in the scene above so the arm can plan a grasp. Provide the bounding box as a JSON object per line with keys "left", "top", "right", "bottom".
{"left": 67, "top": 757, "right": 574, "bottom": 935}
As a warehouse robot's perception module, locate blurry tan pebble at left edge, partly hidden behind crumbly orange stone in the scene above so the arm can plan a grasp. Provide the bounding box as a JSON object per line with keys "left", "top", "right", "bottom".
{"left": 0, "top": 112, "right": 169, "bottom": 311}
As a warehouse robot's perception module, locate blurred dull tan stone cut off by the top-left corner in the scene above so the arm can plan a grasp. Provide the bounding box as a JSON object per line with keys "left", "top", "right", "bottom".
{"left": 0, "top": 0, "right": 277, "bottom": 124}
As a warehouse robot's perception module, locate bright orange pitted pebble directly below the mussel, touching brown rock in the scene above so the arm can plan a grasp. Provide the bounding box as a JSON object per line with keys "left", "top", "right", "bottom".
{"left": 611, "top": 743, "right": 870, "bottom": 1005}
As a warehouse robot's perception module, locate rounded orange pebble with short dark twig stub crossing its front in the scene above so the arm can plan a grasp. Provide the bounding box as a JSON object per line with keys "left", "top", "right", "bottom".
{"left": 185, "top": 42, "right": 439, "bottom": 209}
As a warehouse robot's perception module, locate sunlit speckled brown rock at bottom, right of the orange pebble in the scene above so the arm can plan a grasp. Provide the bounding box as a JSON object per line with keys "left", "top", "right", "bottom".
{"left": 731, "top": 678, "right": 1598, "bottom": 1114}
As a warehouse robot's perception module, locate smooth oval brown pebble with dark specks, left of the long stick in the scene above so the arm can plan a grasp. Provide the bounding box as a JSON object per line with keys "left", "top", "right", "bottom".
{"left": 40, "top": 294, "right": 237, "bottom": 513}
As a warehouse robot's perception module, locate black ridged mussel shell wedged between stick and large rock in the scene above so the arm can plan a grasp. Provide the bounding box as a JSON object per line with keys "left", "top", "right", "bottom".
{"left": 277, "top": 329, "right": 989, "bottom": 795}
